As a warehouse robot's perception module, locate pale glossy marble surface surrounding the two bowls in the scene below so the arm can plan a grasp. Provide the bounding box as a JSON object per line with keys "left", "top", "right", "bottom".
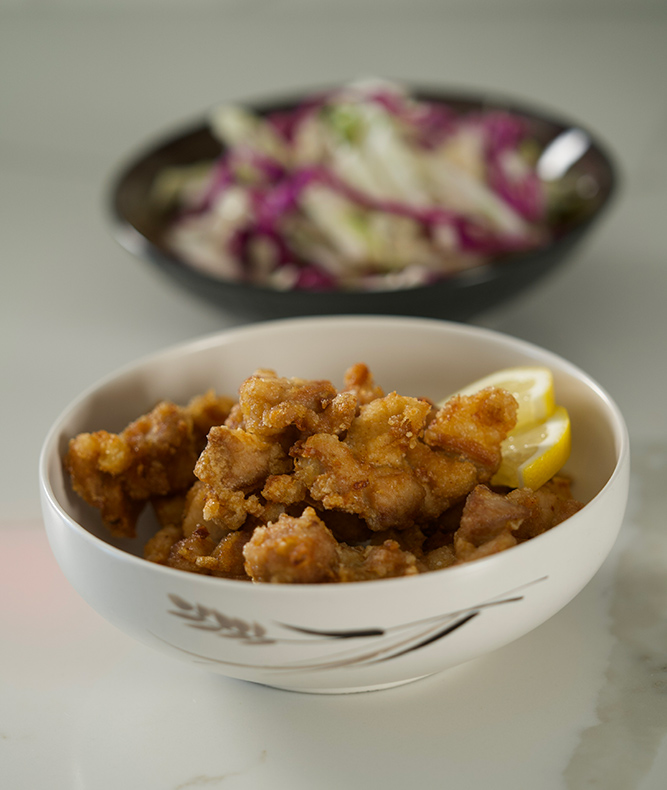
{"left": 0, "top": 0, "right": 667, "bottom": 790}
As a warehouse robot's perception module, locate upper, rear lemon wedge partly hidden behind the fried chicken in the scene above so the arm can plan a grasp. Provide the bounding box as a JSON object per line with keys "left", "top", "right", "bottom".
{"left": 448, "top": 365, "right": 556, "bottom": 431}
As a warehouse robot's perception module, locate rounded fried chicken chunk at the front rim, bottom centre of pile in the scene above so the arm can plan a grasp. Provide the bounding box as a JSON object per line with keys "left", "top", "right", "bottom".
{"left": 243, "top": 507, "right": 338, "bottom": 584}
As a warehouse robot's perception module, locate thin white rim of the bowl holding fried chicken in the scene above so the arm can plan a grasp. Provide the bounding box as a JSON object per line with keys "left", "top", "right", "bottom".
{"left": 38, "top": 315, "right": 630, "bottom": 596}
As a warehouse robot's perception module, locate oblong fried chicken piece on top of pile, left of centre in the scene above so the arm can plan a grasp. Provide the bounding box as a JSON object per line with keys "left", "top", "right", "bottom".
{"left": 239, "top": 371, "right": 357, "bottom": 437}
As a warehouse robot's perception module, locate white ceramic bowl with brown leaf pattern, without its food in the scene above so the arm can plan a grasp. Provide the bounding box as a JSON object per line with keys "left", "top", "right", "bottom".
{"left": 40, "top": 317, "right": 629, "bottom": 693}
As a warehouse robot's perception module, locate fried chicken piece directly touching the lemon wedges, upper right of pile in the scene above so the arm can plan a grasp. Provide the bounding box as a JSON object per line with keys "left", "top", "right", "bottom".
{"left": 424, "top": 387, "right": 518, "bottom": 483}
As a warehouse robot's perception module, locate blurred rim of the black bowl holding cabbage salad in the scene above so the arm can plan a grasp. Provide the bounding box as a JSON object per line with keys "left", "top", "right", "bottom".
{"left": 105, "top": 80, "right": 620, "bottom": 301}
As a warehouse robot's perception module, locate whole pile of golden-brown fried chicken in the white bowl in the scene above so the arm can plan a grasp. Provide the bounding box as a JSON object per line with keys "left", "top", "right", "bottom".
{"left": 65, "top": 363, "right": 581, "bottom": 584}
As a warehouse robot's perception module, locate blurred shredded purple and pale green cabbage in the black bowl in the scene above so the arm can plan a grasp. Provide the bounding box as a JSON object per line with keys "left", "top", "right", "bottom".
{"left": 155, "top": 80, "right": 548, "bottom": 290}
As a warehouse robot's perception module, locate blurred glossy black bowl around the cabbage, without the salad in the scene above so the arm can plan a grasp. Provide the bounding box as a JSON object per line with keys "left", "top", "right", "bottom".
{"left": 111, "top": 88, "right": 617, "bottom": 321}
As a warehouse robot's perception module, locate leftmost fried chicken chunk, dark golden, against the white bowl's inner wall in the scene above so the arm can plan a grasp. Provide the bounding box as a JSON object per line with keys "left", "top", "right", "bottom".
{"left": 64, "top": 392, "right": 230, "bottom": 537}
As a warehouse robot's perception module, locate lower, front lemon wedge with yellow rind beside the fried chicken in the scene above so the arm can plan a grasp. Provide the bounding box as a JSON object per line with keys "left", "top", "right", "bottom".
{"left": 491, "top": 406, "right": 572, "bottom": 491}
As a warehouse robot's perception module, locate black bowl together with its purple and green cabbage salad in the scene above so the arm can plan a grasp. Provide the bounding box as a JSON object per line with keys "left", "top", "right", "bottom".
{"left": 112, "top": 80, "right": 615, "bottom": 320}
